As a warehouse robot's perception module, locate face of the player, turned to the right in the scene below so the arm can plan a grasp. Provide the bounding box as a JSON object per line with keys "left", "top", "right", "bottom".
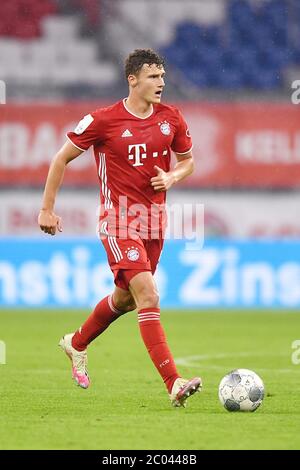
{"left": 135, "top": 64, "right": 165, "bottom": 103}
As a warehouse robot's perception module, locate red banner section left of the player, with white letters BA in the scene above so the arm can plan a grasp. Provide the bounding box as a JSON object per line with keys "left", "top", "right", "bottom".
{"left": 0, "top": 103, "right": 97, "bottom": 186}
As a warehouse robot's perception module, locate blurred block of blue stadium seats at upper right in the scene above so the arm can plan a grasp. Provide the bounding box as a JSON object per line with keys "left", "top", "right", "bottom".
{"left": 164, "top": 0, "right": 300, "bottom": 90}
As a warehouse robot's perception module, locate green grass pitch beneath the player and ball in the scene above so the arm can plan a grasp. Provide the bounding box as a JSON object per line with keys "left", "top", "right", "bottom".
{"left": 0, "top": 310, "right": 300, "bottom": 450}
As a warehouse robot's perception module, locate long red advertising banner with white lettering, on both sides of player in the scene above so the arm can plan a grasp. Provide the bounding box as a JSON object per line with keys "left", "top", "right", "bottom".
{"left": 0, "top": 102, "right": 300, "bottom": 188}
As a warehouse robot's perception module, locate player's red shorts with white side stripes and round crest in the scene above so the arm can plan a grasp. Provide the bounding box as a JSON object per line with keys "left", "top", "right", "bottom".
{"left": 101, "top": 236, "right": 164, "bottom": 290}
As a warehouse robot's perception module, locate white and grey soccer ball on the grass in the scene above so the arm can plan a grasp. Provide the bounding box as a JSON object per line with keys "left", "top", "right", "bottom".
{"left": 219, "top": 369, "right": 264, "bottom": 411}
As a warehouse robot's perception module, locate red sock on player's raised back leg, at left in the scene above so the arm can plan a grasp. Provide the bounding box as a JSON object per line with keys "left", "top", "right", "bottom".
{"left": 72, "top": 295, "right": 123, "bottom": 351}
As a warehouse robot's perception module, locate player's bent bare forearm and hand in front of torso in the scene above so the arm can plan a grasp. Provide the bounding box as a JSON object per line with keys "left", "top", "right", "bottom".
{"left": 151, "top": 152, "right": 194, "bottom": 191}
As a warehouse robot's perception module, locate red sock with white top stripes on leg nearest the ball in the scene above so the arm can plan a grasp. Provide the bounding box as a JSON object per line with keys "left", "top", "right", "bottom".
{"left": 138, "top": 308, "right": 180, "bottom": 393}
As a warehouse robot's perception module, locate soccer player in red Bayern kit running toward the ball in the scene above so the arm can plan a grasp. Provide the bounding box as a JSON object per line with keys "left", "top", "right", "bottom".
{"left": 38, "top": 49, "right": 202, "bottom": 406}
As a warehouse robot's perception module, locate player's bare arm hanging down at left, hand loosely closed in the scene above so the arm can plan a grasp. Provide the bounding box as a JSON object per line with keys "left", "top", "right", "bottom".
{"left": 38, "top": 142, "right": 82, "bottom": 235}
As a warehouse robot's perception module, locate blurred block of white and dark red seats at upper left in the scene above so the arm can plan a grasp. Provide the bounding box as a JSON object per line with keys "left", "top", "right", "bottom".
{"left": 0, "top": 4, "right": 117, "bottom": 92}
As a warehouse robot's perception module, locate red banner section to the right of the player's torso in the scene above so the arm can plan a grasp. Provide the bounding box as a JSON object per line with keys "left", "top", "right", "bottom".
{"left": 182, "top": 102, "right": 300, "bottom": 188}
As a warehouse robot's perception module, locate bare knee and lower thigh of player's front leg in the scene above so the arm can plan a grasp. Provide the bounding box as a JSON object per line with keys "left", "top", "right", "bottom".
{"left": 129, "top": 271, "right": 159, "bottom": 309}
